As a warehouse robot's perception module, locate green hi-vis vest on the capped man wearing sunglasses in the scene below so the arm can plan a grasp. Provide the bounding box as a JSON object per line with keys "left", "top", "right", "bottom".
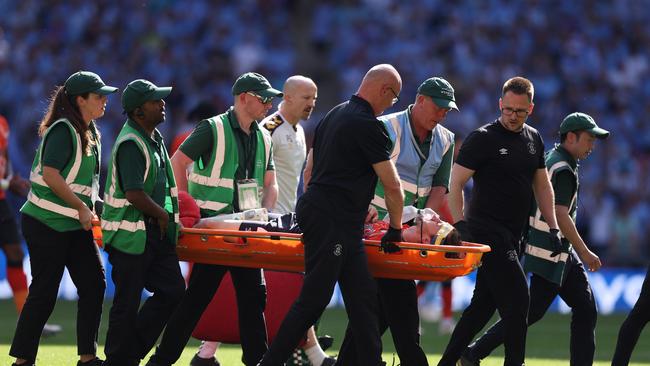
{"left": 187, "top": 112, "right": 271, "bottom": 216}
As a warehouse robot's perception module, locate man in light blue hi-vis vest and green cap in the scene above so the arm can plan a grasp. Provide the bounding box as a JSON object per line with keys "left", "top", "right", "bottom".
{"left": 338, "top": 77, "right": 458, "bottom": 366}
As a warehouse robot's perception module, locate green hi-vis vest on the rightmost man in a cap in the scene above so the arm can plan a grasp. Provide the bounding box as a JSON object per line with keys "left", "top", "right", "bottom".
{"left": 524, "top": 146, "right": 578, "bottom": 284}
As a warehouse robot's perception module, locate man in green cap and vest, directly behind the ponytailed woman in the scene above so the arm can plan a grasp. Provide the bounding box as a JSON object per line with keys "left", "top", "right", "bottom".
{"left": 102, "top": 79, "right": 185, "bottom": 366}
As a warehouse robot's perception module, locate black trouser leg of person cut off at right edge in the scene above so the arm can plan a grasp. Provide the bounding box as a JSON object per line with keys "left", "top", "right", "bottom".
{"left": 612, "top": 267, "right": 650, "bottom": 366}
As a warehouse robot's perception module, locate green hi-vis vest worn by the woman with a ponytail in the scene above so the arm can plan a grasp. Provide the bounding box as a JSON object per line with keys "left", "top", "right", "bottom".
{"left": 20, "top": 119, "right": 101, "bottom": 231}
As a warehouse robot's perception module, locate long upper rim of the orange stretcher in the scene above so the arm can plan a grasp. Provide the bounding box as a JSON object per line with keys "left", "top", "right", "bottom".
{"left": 181, "top": 228, "right": 491, "bottom": 253}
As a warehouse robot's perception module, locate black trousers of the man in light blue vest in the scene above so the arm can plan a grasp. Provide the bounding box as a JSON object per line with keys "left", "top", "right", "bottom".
{"left": 338, "top": 278, "right": 429, "bottom": 366}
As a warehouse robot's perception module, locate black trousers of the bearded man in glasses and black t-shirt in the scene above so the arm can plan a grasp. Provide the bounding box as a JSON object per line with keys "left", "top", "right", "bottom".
{"left": 438, "top": 226, "right": 529, "bottom": 366}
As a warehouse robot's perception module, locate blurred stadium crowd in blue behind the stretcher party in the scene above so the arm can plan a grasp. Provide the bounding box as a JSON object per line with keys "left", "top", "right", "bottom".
{"left": 0, "top": 0, "right": 650, "bottom": 266}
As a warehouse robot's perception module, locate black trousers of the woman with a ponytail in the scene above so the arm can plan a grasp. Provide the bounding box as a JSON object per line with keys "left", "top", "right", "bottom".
{"left": 9, "top": 215, "right": 106, "bottom": 361}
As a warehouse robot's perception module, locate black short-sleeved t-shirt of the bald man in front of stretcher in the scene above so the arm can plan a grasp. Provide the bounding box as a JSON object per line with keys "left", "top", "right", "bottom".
{"left": 303, "top": 95, "right": 392, "bottom": 224}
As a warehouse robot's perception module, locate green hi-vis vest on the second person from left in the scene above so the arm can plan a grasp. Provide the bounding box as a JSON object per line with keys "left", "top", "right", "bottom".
{"left": 102, "top": 122, "right": 179, "bottom": 254}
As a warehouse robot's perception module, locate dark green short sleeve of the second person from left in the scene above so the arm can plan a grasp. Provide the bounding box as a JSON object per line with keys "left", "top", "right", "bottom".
{"left": 117, "top": 141, "right": 147, "bottom": 192}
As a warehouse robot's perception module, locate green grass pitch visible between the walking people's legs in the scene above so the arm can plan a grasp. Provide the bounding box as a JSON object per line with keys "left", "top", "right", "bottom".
{"left": 0, "top": 300, "right": 650, "bottom": 366}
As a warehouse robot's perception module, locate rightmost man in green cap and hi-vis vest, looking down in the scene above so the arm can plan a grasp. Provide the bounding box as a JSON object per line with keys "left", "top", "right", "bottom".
{"left": 463, "top": 112, "right": 609, "bottom": 366}
